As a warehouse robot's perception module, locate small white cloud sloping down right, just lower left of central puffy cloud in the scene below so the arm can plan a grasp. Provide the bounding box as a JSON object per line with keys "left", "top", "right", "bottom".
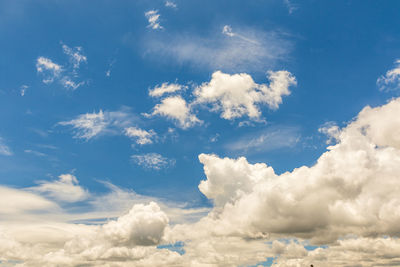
{"left": 151, "top": 96, "right": 202, "bottom": 129}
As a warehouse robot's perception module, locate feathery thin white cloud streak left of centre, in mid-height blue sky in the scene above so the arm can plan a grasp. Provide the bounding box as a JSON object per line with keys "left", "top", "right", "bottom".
{"left": 58, "top": 108, "right": 137, "bottom": 140}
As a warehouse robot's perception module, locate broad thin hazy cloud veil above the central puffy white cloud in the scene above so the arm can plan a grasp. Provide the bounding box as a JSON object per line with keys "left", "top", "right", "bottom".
{"left": 142, "top": 25, "right": 293, "bottom": 72}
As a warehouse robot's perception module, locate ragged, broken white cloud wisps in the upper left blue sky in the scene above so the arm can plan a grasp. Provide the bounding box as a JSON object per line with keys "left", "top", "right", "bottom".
{"left": 36, "top": 42, "right": 87, "bottom": 90}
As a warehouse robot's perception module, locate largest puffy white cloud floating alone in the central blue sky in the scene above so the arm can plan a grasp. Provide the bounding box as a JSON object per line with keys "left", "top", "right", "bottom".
{"left": 194, "top": 71, "right": 296, "bottom": 120}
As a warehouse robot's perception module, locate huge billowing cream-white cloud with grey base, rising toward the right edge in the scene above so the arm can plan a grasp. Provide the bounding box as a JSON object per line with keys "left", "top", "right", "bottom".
{"left": 194, "top": 99, "right": 400, "bottom": 242}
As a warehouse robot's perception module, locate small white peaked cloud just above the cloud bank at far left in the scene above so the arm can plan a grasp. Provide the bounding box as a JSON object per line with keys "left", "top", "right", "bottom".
{"left": 30, "top": 174, "right": 89, "bottom": 202}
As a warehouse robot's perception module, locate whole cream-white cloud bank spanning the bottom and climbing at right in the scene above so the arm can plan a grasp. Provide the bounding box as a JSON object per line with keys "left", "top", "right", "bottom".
{"left": 0, "top": 98, "right": 400, "bottom": 266}
